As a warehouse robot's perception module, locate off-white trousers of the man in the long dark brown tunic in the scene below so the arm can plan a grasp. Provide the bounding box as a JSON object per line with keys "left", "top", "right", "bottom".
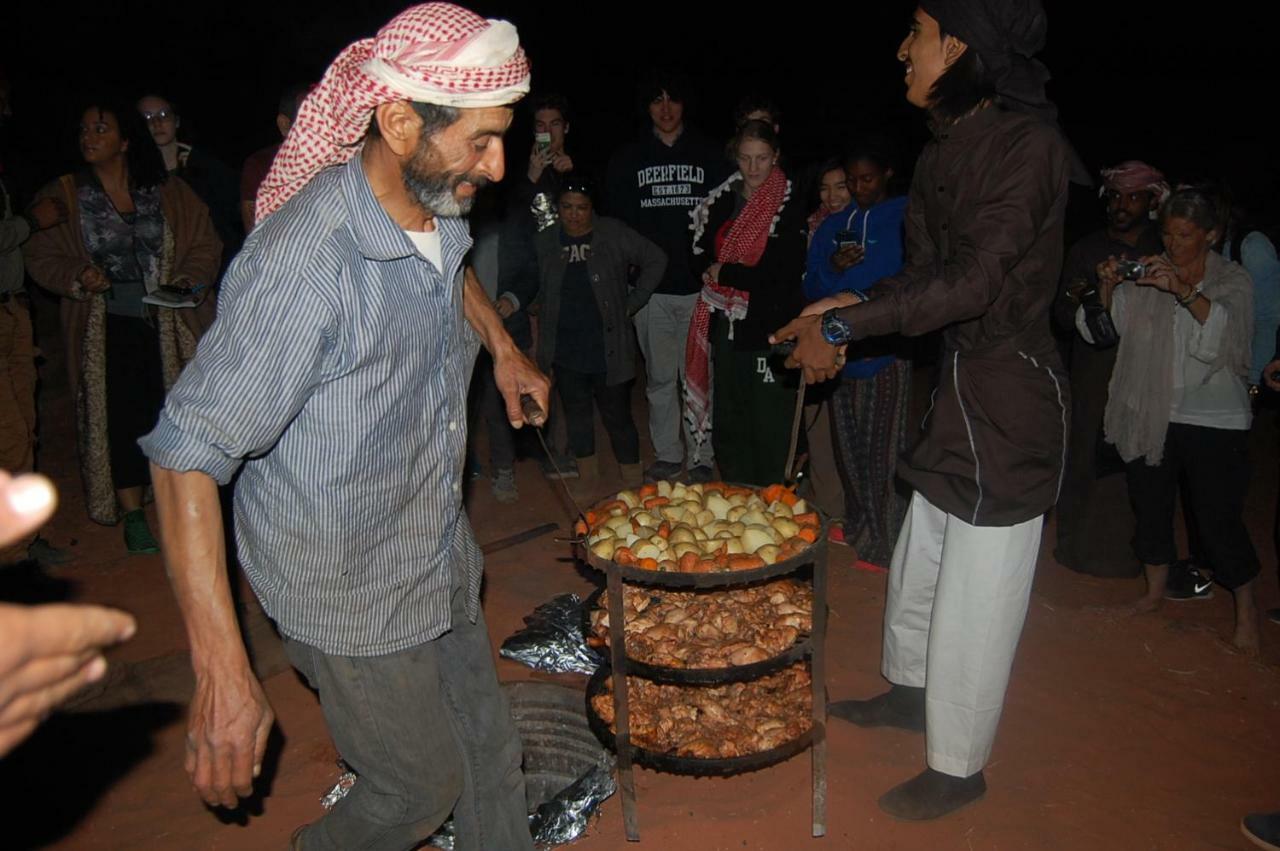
{"left": 881, "top": 493, "right": 1043, "bottom": 777}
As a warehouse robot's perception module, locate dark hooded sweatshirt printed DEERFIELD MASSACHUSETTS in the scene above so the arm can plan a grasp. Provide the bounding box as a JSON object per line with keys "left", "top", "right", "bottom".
{"left": 605, "top": 125, "right": 732, "bottom": 296}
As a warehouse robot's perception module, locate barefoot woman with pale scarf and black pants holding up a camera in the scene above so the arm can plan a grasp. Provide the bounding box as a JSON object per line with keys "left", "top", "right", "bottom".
{"left": 1076, "top": 188, "right": 1258, "bottom": 654}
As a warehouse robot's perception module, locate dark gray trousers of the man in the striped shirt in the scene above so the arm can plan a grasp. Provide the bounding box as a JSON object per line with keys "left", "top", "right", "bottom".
{"left": 285, "top": 578, "right": 534, "bottom": 851}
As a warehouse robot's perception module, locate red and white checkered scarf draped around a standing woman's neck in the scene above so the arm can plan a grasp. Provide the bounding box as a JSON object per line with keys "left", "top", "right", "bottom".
{"left": 685, "top": 161, "right": 791, "bottom": 445}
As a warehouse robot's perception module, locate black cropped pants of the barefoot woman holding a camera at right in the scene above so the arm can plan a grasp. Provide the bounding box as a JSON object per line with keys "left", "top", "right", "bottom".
{"left": 1126, "top": 422, "right": 1258, "bottom": 589}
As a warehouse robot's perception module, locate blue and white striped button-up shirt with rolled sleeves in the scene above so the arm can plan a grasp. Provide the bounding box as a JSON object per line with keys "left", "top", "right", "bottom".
{"left": 141, "top": 156, "right": 481, "bottom": 656}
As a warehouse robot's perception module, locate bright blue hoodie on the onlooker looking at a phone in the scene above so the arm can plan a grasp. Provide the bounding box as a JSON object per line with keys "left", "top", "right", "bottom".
{"left": 804, "top": 195, "right": 906, "bottom": 379}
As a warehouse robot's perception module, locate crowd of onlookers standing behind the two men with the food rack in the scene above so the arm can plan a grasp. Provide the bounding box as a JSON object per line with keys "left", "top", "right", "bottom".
{"left": 0, "top": 70, "right": 1280, "bottom": 616}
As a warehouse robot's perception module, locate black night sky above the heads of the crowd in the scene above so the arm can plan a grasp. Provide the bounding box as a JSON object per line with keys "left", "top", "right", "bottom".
{"left": 0, "top": 0, "right": 1277, "bottom": 224}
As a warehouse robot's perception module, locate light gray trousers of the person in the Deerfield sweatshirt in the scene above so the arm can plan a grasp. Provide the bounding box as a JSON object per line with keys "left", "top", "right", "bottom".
{"left": 635, "top": 293, "right": 716, "bottom": 468}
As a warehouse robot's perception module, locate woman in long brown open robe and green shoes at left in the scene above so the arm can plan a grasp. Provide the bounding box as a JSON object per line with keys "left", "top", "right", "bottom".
{"left": 23, "top": 101, "right": 221, "bottom": 553}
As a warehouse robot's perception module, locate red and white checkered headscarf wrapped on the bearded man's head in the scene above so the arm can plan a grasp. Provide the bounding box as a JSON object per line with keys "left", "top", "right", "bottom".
{"left": 255, "top": 3, "right": 529, "bottom": 221}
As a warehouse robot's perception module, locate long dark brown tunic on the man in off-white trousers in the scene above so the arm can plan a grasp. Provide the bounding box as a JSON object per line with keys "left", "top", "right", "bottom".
{"left": 842, "top": 106, "right": 1070, "bottom": 526}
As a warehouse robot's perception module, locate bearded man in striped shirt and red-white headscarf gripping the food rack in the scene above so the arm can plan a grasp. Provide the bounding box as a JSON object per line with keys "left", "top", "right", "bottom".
{"left": 142, "top": 3, "right": 549, "bottom": 851}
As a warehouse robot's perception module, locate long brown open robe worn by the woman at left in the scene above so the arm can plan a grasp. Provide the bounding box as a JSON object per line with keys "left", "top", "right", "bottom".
{"left": 23, "top": 174, "right": 223, "bottom": 525}
